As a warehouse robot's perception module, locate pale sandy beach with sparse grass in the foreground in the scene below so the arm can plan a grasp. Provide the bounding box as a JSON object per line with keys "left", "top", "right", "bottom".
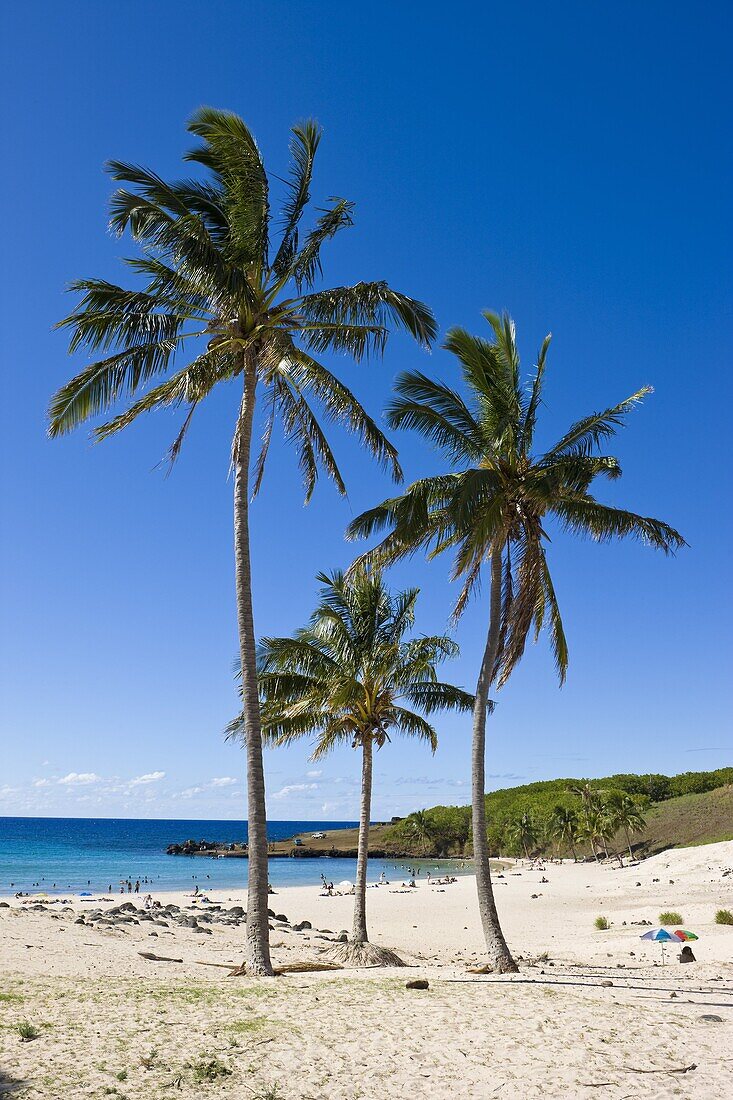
{"left": 0, "top": 842, "right": 733, "bottom": 1100}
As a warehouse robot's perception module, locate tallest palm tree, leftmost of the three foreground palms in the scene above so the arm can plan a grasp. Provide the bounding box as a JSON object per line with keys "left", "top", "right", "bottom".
{"left": 50, "top": 108, "right": 435, "bottom": 974}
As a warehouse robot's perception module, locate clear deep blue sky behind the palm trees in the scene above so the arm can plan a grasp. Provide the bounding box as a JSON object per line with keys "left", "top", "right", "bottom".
{"left": 0, "top": 0, "right": 733, "bottom": 820}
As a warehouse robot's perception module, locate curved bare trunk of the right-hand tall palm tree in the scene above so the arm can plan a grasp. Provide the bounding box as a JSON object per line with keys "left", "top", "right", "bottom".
{"left": 471, "top": 550, "right": 518, "bottom": 974}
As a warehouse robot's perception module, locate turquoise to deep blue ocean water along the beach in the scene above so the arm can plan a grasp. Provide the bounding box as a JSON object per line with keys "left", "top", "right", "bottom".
{"left": 0, "top": 817, "right": 445, "bottom": 895}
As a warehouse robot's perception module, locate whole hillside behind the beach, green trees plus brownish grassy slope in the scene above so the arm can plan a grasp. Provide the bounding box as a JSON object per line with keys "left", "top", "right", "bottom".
{"left": 380, "top": 768, "right": 733, "bottom": 857}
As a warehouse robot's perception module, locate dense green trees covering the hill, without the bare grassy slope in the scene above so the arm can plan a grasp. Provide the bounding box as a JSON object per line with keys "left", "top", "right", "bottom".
{"left": 383, "top": 768, "right": 733, "bottom": 858}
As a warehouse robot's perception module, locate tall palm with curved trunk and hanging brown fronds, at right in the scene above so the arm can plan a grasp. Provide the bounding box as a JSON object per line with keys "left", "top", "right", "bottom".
{"left": 349, "top": 312, "right": 685, "bottom": 971}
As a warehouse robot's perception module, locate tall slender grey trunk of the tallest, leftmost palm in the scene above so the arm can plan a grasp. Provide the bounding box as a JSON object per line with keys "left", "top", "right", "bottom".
{"left": 234, "top": 363, "right": 273, "bottom": 975}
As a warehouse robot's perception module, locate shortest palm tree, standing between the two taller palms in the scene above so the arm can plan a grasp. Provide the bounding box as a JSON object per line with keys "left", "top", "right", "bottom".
{"left": 234, "top": 568, "right": 473, "bottom": 965}
